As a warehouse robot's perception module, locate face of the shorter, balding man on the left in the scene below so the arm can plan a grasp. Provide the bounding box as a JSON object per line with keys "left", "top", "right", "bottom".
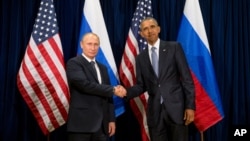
{"left": 81, "top": 34, "right": 100, "bottom": 59}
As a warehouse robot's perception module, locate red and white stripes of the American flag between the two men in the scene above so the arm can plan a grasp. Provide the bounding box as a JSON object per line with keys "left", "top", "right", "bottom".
{"left": 119, "top": 28, "right": 150, "bottom": 141}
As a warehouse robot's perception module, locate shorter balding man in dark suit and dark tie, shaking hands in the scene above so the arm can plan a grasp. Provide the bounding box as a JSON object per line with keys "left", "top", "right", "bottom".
{"left": 66, "top": 33, "right": 122, "bottom": 141}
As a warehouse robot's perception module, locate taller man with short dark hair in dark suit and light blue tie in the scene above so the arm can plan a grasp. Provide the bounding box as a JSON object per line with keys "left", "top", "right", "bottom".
{"left": 120, "top": 17, "right": 195, "bottom": 141}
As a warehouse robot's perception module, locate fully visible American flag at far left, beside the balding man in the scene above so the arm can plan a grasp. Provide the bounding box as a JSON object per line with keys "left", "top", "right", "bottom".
{"left": 17, "top": 0, "right": 69, "bottom": 135}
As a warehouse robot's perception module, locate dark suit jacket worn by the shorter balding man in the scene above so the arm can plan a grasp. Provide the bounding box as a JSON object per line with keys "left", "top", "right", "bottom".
{"left": 66, "top": 55, "right": 115, "bottom": 133}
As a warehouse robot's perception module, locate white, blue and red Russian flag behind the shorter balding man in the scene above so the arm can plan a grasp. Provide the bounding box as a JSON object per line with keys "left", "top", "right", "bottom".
{"left": 77, "top": 0, "right": 125, "bottom": 117}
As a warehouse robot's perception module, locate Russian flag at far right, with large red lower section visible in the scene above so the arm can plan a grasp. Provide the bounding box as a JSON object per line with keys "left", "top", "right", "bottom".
{"left": 177, "top": 0, "right": 224, "bottom": 132}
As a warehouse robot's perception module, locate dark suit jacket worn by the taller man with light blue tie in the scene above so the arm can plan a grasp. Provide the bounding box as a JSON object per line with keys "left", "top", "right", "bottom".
{"left": 127, "top": 40, "right": 195, "bottom": 127}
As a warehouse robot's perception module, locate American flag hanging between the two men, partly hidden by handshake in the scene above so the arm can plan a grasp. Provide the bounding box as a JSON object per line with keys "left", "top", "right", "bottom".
{"left": 119, "top": 0, "right": 153, "bottom": 141}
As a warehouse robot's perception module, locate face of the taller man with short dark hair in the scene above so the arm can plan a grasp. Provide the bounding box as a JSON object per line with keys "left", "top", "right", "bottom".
{"left": 140, "top": 20, "right": 160, "bottom": 45}
